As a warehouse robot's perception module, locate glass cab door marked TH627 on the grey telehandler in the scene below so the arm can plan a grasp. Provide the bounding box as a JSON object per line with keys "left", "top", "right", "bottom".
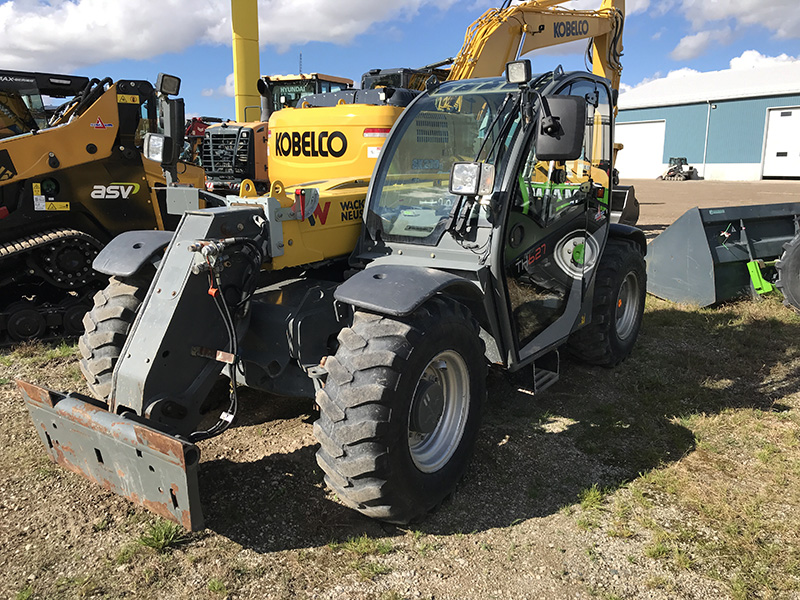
{"left": 503, "top": 80, "right": 611, "bottom": 363}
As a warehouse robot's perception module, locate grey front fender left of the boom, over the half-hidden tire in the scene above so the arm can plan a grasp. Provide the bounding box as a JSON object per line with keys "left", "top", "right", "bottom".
{"left": 92, "top": 230, "right": 174, "bottom": 277}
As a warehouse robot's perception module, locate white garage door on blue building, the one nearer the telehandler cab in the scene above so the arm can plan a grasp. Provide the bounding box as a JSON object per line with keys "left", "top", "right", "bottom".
{"left": 614, "top": 121, "right": 667, "bottom": 179}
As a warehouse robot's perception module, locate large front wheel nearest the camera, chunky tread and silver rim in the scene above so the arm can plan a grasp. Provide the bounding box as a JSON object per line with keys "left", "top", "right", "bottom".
{"left": 314, "top": 297, "right": 486, "bottom": 524}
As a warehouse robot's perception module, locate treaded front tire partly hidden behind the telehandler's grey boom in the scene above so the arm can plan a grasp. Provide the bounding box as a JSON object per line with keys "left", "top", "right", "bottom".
{"left": 78, "top": 276, "right": 150, "bottom": 401}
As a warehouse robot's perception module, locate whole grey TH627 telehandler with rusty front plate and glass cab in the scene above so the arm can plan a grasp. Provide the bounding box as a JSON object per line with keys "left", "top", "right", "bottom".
{"left": 19, "top": 61, "right": 646, "bottom": 529}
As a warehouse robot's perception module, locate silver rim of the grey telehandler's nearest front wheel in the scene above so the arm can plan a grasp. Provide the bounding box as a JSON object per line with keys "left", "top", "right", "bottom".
{"left": 408, "top": 350, "right": 469, "bottom": 473}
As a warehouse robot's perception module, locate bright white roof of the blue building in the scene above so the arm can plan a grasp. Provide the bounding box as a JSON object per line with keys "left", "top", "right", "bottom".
{"left": 619, "top": 61, "right": 800, "bottom": 110}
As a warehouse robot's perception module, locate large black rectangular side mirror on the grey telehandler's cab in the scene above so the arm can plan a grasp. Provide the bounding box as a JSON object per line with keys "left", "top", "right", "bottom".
{"left": 536, "top": 96, "right": 586, "bottom": 161}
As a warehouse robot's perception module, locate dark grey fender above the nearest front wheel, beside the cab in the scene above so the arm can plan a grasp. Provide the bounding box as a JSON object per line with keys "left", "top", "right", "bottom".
{"left": 334, "top": 265, "right": 480, "bottom": 317}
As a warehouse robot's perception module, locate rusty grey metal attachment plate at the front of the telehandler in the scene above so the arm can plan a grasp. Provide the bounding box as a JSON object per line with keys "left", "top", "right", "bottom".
{"left": 17, "top": 380, "right": 203, "bottom": 531}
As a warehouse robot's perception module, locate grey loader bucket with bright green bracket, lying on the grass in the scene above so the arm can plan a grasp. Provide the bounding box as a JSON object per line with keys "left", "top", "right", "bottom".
{"left": 647, "top": 202, "right": 800, "bottom": 306}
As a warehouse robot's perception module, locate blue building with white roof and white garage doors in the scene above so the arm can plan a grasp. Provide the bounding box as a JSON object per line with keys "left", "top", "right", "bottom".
{"left": 615, "top": 62, "right": 800, "bottom": 181}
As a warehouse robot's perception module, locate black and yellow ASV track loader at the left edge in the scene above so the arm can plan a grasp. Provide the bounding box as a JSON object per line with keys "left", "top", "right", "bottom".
{"left": 0, "top": 71, "right": 204, "bottom": 345}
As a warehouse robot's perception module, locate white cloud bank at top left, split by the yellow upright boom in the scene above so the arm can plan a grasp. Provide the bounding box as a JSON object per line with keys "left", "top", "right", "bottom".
{"left": 0, "top": 0, "right": 456, "bottom": 71}
